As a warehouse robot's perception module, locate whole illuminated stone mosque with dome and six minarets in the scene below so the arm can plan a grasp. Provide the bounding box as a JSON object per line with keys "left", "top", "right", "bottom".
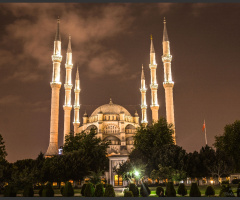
{"left": 45, "top": 19, "right": 176, "bottom": 186}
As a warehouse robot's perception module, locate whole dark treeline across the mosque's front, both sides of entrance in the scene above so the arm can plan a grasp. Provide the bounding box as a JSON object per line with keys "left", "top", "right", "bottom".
{"left": 0, "top": 118, "right": 240, "bottom": 191}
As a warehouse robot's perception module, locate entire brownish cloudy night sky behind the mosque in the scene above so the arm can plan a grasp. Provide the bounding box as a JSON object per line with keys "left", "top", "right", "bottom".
{"left": 0, "top": 3, "right": 240, "bottom": 162}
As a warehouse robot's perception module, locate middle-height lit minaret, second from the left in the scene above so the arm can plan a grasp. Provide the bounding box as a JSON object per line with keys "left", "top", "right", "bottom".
{"left": 63, "top": 36, "right": 73, "bottom": 144}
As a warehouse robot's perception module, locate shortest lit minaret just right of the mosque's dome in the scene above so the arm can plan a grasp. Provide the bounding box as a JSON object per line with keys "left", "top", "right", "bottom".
{"left": 140, "top": 65, "right": 148, "bottom": 126}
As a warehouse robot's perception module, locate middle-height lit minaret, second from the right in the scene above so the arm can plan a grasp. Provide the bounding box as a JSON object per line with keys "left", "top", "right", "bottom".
{"left": 149, "top": 35, "right": 159, "bottom": 122}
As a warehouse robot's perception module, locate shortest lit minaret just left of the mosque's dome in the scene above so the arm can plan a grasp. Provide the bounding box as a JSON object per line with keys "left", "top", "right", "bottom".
{"left": 73, "top": 68, "right": 81, "bottom": 134}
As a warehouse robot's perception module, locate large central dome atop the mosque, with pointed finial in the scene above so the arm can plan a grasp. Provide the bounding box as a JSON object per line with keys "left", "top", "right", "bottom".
{"left": 91, "top": 99, "right": 131, "bottom": 116}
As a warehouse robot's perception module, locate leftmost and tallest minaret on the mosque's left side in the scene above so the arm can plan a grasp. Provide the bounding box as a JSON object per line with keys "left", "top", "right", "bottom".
{"left": 45, "top": 18, "right": 62, "bottom": 156}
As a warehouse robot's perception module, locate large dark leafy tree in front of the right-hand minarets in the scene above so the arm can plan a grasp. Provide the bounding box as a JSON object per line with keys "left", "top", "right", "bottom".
{"left": 129, "top": 118, "right": 183, "bottom": 176}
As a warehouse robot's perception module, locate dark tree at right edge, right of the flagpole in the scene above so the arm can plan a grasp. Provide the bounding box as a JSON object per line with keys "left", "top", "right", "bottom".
{"left": 214, "top": 120, "right": 240, "bottom": 172}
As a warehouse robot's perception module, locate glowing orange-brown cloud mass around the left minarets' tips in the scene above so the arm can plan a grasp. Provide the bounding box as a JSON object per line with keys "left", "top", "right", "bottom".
{"left": 0, "top": 3, "right": 134, "bottom": 82}
